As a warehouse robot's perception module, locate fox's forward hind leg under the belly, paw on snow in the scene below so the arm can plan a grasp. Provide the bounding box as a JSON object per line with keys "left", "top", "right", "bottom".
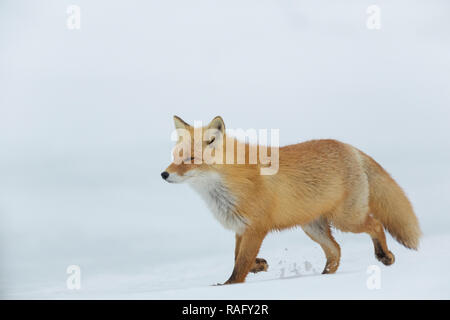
{"left": 302, "top": 217, "right": 341, "bottom": 274}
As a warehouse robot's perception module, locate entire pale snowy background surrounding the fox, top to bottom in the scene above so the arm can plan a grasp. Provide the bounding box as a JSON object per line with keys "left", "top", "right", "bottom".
{"left": 0, "top": 0, "right": 450, "bottom": 299}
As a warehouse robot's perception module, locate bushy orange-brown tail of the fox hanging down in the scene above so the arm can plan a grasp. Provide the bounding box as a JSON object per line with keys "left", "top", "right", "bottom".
{"left": 361, "top": 152, "right": 422, "bottom": 250}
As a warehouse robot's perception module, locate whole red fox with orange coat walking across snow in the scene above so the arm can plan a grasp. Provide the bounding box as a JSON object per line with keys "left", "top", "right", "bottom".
{"left": 161, "top": 116, "right": 421, "bottom": 284}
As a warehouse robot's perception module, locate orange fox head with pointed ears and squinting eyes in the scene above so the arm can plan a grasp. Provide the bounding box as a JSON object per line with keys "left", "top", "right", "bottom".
{"left": 161, "top": 116, "right": 225, "bottom": 183}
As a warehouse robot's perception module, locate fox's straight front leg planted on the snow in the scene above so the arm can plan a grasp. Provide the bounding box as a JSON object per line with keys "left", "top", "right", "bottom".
{"left": 224, "top": 229, "right": 267, "bottom": 284}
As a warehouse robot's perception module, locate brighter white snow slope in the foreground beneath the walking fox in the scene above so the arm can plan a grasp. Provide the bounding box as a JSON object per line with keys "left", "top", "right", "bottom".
{"left": 3, "top": 218, "right": 450, "bottom": 299}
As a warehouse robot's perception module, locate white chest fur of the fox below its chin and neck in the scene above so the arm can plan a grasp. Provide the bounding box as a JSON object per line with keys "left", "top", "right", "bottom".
{"left": 190, "top": 173, "right": 247, "bottom": 234}
